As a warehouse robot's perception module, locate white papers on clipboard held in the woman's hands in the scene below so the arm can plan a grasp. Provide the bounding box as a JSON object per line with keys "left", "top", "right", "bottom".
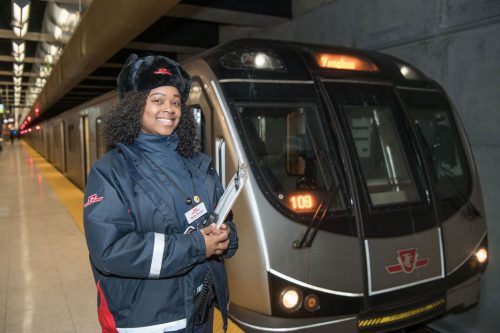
{"left": 212, "top": 163, "right": 248, "bottom": 228}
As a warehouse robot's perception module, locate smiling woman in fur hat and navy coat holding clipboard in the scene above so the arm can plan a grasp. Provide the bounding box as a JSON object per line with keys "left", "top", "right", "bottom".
{"left": 84, "top": 54, "right": 238, "bottom": 333}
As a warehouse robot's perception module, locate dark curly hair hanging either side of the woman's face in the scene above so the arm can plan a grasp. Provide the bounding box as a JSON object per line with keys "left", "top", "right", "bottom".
{"left": 104, "top": 91, "right": 200, "bottom": 157}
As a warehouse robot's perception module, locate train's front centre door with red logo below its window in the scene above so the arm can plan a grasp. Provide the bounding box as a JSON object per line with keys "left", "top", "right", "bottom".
{"left": 323, "top": 80, "right": 445, "bottom": 320}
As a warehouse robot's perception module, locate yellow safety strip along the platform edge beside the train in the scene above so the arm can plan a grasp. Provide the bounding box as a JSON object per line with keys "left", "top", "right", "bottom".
{"left": 22, "top": 141, "right": 244, "bottom": 333}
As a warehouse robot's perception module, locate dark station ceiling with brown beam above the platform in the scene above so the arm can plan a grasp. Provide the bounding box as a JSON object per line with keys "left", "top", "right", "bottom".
{"left": 0, "top": 0, "right": 292, "bottom": 122}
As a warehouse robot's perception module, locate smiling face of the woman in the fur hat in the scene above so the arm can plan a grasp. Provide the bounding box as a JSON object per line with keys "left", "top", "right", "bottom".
{"left": 141, "top": 86, "right": 181, "bottom": 135}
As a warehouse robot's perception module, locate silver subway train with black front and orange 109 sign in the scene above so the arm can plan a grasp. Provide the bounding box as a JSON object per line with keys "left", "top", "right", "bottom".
{"left": 24, "top": 39, "right": 488, "bottom": 333}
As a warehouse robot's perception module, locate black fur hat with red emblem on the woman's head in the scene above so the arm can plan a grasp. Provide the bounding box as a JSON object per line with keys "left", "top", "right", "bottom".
{"left": 117, "top": 54, "right": 191, "bottom": 103}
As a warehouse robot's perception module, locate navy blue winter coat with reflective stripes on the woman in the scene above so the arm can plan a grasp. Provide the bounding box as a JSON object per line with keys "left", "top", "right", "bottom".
{"left": 84, "top": 133, "right": 238, "bottom": 333}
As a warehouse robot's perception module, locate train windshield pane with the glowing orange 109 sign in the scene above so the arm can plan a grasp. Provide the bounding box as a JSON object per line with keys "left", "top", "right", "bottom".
{"left": 238, "top": 105, "right": 344, "bottom": 213}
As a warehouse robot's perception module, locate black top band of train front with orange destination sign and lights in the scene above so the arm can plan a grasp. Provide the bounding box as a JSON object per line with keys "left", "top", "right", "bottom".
{"left": 188, "top": 39, "right": 438, "bottom": 89}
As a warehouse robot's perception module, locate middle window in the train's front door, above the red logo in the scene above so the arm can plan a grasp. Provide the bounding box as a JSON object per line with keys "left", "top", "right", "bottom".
{"left": 326, "top": 82, "right": 421, "bottom": 206}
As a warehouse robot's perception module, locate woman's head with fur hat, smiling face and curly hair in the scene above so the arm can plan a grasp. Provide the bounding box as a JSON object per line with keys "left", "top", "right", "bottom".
{"left": 104, "top": 54, "right": 200, "bottom": 157}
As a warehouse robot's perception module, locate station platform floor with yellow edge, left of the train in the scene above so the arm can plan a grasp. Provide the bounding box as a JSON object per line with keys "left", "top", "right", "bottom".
{"left": 0, "top": 141, "right": 242, "bottom": 333}
